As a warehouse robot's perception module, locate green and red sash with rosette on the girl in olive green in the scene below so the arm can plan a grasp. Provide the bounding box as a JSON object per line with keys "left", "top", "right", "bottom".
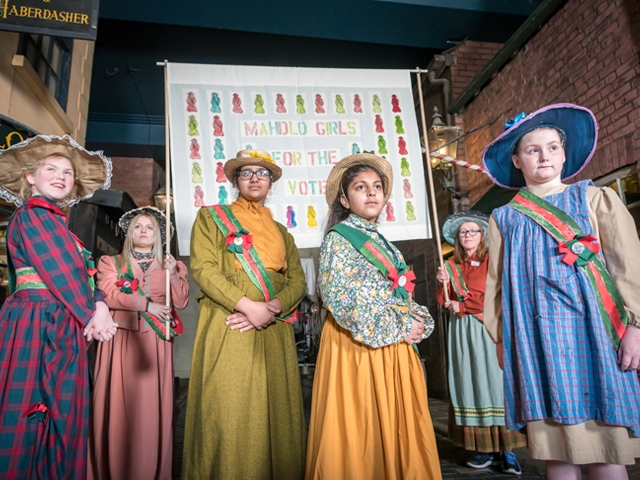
{"left": 208, "top": 205, "right": 296, "bottom": 323}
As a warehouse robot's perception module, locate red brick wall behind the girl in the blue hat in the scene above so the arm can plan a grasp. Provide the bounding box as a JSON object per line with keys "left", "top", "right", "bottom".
{"left": 452, "top": 0, "right": 640, "bottom": 203}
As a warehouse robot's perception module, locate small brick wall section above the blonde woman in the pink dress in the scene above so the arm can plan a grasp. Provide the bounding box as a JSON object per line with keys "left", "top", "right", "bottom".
{"left": 111, "top": 157, "right": 164, "bottom": 207}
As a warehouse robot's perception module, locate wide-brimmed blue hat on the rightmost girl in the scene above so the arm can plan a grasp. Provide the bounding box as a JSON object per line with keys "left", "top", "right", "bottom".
{"left": 482, "top": 103, "right": 598, "bottom": 190}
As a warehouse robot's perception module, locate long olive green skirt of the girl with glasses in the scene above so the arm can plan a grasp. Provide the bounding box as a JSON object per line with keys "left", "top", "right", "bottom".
{"left": 182, "top": 272, "right": 306, "bottom": 480}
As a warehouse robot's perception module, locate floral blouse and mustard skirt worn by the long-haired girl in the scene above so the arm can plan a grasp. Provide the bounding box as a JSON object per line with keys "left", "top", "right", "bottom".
{"left": 305, "top": 215, "right": 442, "bottom": 480}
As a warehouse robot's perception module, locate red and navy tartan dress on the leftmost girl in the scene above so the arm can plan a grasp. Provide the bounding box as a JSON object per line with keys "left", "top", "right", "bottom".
{"left": 0, "top": 197, "right": 103, "bottom": 479}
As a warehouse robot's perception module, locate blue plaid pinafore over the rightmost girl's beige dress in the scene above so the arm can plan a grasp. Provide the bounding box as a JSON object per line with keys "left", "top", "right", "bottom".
{"left": 493, "top": 181, "right": 640, "bottom": 436}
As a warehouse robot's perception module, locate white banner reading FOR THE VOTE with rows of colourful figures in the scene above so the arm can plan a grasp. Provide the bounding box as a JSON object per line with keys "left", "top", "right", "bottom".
{"left": 167, "top": 63, "right": 431, "bottom": 255}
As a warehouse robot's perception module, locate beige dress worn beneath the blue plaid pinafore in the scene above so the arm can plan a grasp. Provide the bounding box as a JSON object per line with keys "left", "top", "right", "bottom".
{"left": 484, "top": 185, "right": 640, "bottom": 465}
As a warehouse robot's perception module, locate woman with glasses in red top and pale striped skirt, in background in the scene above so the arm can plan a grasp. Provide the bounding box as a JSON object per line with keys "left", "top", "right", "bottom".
{"left": 436, "top": 212, "right": 526, "bottom": 475}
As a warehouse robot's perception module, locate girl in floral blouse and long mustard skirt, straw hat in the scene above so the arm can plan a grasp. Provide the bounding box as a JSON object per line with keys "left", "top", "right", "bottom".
{"left": 306, "top": 154, "right": 441, "bottom": 480}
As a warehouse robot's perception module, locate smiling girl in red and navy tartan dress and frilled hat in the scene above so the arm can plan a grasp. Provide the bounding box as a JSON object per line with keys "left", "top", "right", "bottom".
{"left": 0, "top": 136, "right": 117, "bottom": 479}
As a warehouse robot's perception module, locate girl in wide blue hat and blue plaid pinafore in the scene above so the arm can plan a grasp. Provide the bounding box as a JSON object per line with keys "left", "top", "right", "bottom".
{"left": 483, "top": 104, "right": 640, "bottom": 480}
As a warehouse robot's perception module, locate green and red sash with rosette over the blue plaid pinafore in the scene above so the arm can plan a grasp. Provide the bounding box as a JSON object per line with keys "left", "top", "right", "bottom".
{"left": 509, "top": 190, "right": 629, "bottom": 350}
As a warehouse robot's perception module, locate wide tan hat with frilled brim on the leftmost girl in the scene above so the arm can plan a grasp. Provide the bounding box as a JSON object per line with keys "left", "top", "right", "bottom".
{"left": 0, "top": 135, "right": 111, "bottom": 206}
